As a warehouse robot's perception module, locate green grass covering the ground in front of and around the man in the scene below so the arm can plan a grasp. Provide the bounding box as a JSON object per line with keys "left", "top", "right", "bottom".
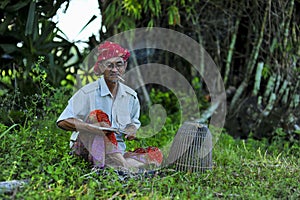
{"left": 0, "top": 116, "right": 300, "bottom": 199}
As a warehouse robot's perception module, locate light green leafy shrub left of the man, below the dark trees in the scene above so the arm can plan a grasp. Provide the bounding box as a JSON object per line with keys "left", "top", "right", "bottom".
{"left": 0, "top": 57, "right": 71, "bottom": 126}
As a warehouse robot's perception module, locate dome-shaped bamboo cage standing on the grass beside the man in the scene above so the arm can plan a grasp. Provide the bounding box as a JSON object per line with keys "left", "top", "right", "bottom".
{"left": 166, "top": 122, "right": 212, "bottom": 172}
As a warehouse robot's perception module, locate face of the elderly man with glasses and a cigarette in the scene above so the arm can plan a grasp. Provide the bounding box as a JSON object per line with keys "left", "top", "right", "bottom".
{"left": 102, "top": 57, "right": 127, "bottom": 82}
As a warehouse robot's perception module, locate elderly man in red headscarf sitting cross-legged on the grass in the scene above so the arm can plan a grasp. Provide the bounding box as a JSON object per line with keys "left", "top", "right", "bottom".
{"left": 57, "top": 41, "right": 162, "bottom": 169}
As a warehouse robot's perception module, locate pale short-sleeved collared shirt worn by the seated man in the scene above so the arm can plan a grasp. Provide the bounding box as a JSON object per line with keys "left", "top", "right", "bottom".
{"left": 56, "top": 77, "right": 141, "bottom": 152}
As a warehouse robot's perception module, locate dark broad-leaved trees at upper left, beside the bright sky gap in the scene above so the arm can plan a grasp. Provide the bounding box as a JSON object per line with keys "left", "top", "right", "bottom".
{"left": 0, "top": 0, "right": 81, "bottom": 95}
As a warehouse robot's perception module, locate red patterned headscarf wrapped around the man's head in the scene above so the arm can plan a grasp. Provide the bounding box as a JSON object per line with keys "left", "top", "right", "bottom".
{"left": 94, "top": 41, "right": 130, "bottom": 74}
